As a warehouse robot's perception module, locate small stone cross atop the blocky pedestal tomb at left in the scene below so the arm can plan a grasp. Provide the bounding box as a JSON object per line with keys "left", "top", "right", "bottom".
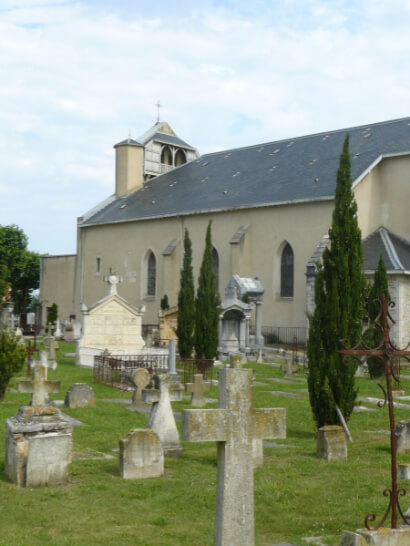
{"left": 17, "top": 351, "right": 60, "bottom": 408}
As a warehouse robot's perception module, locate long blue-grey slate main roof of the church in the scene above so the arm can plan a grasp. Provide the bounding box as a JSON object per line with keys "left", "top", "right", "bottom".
{"left": 82, "top": 117, "right": 410, "bottom": 226}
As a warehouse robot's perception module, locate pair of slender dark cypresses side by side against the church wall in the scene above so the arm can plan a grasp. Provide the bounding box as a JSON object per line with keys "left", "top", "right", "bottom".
{"left": 176, "top": 220, "right": 220, "bottom": 358}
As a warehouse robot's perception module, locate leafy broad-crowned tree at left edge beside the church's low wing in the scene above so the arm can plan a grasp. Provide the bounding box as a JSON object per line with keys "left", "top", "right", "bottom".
{"left": 0, "top": 225, "right": 40, "bottom": 312}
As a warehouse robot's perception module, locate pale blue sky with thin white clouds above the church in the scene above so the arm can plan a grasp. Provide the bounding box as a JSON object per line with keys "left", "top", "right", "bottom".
{"left": 0, "top": 0, "right": 410, "bottom": 255}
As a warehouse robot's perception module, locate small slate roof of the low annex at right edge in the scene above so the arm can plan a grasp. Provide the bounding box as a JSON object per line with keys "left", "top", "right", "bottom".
{"left": 363, "top": 227, "right": 410, "bottom": 271}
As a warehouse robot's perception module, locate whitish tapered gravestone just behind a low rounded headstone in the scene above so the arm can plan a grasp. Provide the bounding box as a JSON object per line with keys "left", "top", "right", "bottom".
{"left": 142, "top": 374, "right": 183, "bottom": 457}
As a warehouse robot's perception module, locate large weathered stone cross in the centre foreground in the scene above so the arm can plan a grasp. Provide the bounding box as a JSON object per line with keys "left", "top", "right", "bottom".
{"left": 182, "top": 368, "right": 286, "bottom": 546}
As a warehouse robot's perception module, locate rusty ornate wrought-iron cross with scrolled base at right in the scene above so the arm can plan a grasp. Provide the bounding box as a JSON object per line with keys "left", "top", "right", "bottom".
{"left": 339, "top": 295, "right": 410, "bottom": 530}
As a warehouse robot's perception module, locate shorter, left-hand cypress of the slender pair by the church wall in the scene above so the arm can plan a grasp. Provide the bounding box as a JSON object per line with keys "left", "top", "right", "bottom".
{"left": 176, "top": 228, "right": 195, "bottom": 358}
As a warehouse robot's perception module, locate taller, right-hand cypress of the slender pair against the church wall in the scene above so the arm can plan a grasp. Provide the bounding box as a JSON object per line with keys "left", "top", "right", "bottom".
{"left": 194, "top": 220, "right": 220, "bottom": 358}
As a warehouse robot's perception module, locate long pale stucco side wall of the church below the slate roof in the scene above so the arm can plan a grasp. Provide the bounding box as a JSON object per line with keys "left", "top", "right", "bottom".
{"left": 74, "top": 201, "right": 333, "bottom": 326}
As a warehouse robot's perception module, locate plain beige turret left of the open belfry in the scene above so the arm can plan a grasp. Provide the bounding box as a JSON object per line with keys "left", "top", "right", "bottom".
{"left": 114, "top": 138, "right": 144, "bottom": 196}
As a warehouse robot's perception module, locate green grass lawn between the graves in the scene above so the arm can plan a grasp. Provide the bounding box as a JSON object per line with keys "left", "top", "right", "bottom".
{"left": 0, "top": 342, "right": 410, "bottom": 546}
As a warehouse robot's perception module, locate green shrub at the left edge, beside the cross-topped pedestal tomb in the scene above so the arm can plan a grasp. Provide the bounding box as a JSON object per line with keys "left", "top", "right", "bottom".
{"left": 0, "top": 328, "right": 27, "bottom": 401}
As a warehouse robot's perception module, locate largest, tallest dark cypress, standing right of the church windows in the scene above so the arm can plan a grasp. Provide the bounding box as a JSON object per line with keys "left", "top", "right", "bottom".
{"left": 307, "top": 136, "right": 366, "bottom": 428}
